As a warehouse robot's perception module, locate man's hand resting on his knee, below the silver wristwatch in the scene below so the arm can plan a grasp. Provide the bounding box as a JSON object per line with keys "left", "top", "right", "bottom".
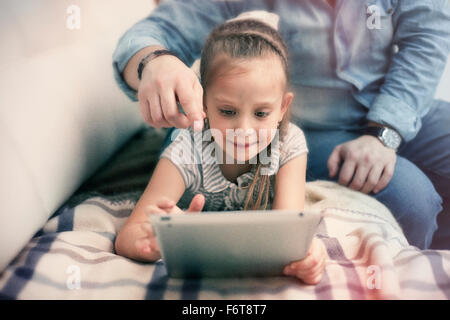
{"left": 328, "top": 135, "right": 397, "bottom": 194}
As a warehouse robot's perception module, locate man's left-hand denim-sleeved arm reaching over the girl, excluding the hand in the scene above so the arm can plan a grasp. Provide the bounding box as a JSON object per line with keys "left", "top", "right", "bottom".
{"left": 113, "top": 0, "right": 246, "bottom": 100}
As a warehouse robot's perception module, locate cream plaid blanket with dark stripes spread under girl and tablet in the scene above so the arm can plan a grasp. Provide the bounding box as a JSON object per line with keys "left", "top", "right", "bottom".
{"left": 0, "top": 129, "right": 450, "bottom": 300}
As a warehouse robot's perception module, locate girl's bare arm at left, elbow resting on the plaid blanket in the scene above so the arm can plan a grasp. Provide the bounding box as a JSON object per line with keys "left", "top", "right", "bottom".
{"left": 115, "top": 158, "right": 185, "bottom": 261}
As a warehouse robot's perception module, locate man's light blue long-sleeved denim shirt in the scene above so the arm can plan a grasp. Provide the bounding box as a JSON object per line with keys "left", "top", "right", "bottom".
{"left": 113, "top": 0, "right": 450, "bottom": 141}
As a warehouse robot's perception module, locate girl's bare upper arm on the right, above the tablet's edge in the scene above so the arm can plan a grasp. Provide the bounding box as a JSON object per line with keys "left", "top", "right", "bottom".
{"left": 272, "top": 153, "right": 307, "bottom": 210}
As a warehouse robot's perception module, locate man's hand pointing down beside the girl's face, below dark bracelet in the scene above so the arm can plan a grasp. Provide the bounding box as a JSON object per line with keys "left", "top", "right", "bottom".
{"left": 138, "top": 55, "right": 206, "bottom": 129}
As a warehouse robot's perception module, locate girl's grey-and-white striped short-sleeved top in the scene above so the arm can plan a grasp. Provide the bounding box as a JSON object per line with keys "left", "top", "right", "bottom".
{"left": 160, "top": 123, "right": 308, "bottom": 211}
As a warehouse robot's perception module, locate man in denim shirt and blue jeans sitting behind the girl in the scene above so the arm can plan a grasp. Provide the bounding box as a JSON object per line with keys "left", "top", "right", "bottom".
{"left": 114, "top": 0, "right": 450, "bottom": 249}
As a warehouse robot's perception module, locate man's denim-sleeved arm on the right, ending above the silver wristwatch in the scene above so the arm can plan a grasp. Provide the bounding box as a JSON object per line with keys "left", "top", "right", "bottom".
{"left": 367, "top": 0, "right": 450, "bottom": 141}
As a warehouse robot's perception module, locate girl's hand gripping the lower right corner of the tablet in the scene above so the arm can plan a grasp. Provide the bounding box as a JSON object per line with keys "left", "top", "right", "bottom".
{"left": 283, "top": 238, "right": 328, "bottom": 284}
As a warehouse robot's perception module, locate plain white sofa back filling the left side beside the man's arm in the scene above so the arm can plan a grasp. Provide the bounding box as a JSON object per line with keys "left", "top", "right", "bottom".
{"left": 0, "top": 0, "right": 153, "bottom": 272}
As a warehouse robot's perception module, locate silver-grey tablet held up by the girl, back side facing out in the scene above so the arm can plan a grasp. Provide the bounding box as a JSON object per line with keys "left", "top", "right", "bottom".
{"left": 149, "top": 210, "right": 321, "bottom": 278}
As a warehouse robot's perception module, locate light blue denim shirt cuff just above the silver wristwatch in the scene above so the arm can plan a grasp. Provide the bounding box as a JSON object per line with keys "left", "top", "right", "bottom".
{"left": 367, "top": 93, "right": 422, "bottom": 142}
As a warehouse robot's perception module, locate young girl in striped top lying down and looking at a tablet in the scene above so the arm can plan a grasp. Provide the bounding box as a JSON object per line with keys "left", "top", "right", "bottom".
{"left": 115, "top": 19, "right": 326, "bottom": 284}
